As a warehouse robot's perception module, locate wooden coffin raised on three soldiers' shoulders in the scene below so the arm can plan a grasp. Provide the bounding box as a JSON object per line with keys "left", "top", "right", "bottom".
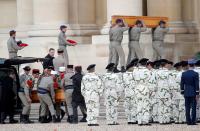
{"left": 112, "top": 15, "right": 169, "bottom": 28}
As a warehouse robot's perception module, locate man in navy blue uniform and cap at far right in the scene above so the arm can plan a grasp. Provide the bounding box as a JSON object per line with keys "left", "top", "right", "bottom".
{"left": 181, "top": 60, "right": 199, "bottom": 125}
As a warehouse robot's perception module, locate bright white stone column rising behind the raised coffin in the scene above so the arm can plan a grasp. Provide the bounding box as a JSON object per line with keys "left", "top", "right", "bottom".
{"left": 101, "top": 0, "right": 143, "bottom": 34}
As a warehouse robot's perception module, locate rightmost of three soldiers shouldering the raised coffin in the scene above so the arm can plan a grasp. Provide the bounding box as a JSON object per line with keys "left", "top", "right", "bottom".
{"left": 152, "top": 20, "right": 169, "bottom": 60}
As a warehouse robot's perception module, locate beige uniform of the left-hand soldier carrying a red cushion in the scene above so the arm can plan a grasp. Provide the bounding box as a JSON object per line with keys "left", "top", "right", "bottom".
{"left": 7, "top": 37, "right": 24, "bottom": 59}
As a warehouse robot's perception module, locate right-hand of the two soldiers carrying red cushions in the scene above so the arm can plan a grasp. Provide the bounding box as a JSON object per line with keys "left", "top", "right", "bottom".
{"left": 58, "top": 25, "right": 72, "bottom": 65}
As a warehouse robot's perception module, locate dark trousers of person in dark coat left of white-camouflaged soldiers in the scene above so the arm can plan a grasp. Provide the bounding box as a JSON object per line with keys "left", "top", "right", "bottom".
{"left": 72, "top": 102, "right": 87, "bottom": 122}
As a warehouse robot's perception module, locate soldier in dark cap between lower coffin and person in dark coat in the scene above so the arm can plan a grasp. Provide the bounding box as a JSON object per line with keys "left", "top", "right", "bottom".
{"left": 62, "top": 65, "right": 74, "bottom": 123}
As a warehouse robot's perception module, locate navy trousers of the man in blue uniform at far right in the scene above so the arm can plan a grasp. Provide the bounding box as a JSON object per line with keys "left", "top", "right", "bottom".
{"left": 185, "top": 97, "right": 197, "bottom": 124}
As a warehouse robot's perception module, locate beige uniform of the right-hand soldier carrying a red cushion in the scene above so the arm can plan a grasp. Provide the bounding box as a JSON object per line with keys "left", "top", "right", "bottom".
{"left": 58, "top": 32, "right": 70, "bottom": 65}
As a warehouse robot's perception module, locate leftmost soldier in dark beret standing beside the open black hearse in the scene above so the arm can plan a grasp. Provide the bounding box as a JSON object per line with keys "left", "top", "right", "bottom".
{"left": 18, "top": 66, "right": 33, "bottom": 124}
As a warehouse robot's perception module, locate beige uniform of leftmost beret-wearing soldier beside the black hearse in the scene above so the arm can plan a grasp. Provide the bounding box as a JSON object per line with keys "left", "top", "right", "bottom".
{"left": 18, "top": 74, "right": 31, "bottom": 115}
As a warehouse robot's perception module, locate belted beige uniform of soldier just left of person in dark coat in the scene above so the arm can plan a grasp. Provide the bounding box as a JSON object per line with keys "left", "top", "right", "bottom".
{"left": 63, "top": 71, "right": 74, "bottom": 116}
